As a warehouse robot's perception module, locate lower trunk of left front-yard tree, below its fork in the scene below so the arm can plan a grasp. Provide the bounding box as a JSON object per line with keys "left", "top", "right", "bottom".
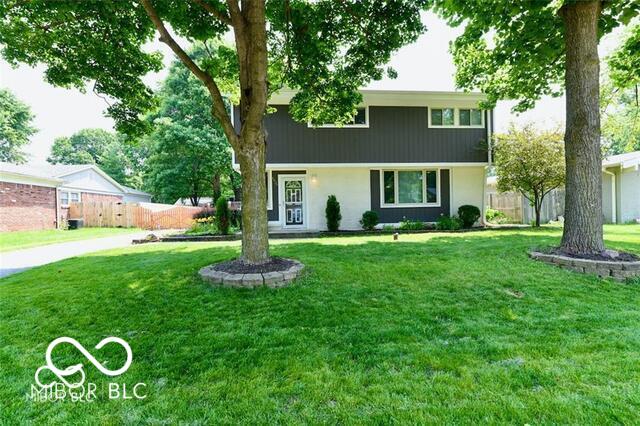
{"left": 237, "top": 133, "right": 269, "bottom": 264}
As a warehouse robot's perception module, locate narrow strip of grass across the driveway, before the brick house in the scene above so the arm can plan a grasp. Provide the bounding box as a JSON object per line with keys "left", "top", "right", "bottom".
{"left": 0, "top": 228, "right": 140, "bottom": 252}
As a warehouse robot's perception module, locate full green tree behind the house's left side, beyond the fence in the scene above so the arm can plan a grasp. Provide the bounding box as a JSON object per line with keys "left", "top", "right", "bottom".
{"left": 146, "top": 46, "right": 232, "bottom": 205}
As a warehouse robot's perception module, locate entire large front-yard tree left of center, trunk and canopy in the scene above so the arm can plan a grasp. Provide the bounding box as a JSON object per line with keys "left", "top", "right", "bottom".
{"left": 0, "top": 0, "right": 425, "bottom": 264}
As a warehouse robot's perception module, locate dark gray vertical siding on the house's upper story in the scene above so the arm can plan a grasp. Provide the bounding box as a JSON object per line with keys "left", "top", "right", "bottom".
{"left": 236, "top": 105, "right": 488, "bottom": 164}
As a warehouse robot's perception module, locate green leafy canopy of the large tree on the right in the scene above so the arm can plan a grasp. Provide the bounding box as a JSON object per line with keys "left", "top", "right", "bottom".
{"left": 433, "top": 0, "right": 640, "bottom": 111}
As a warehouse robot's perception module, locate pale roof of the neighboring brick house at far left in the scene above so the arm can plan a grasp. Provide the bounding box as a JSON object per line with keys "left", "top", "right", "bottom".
{"left": 0, "top": 162, "right": 151, "bottom": 196}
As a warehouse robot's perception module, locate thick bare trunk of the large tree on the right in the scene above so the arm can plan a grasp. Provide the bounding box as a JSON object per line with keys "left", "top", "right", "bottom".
{"left": 560, "top": 0, "right": 604, "bottom": 254}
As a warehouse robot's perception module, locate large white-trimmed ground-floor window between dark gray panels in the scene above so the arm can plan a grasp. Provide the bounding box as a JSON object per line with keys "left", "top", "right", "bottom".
{"left": 380, "top": 169, "right": 440, "bottom": 207}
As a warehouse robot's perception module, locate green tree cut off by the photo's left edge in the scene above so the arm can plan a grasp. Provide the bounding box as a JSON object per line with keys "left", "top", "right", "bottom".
{"left": 0, "top": 89, "right": 37, "bottom": 164}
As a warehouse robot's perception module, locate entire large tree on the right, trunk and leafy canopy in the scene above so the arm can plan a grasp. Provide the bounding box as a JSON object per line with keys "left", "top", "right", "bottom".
{"left": 433, "top": 0, "right": 640, "bottom": 254}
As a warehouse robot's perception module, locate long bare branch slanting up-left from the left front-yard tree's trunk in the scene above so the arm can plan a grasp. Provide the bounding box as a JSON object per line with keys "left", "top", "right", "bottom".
{"left": 141, "top": 0, "right": 238, "bottom": 149}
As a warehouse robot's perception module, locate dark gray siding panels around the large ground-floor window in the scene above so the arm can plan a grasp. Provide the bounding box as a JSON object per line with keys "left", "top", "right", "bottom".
{"left": 370, "top": 169, "right": 451, "bottom": 223}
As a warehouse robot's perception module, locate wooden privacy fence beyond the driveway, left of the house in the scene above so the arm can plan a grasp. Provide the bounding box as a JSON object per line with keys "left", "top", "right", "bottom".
{"left": 69, "top": 201, "right": 203, "bottom": 229}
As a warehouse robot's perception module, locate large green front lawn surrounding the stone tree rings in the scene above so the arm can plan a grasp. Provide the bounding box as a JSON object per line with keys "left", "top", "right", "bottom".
{"left": 0, "top": 226, "right": 640, "bottom": 424}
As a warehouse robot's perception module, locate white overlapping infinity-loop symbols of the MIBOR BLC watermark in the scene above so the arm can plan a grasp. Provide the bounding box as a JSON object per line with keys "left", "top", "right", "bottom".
{"left": 35, "top": 337, "right": 133, "bottom": 389}
